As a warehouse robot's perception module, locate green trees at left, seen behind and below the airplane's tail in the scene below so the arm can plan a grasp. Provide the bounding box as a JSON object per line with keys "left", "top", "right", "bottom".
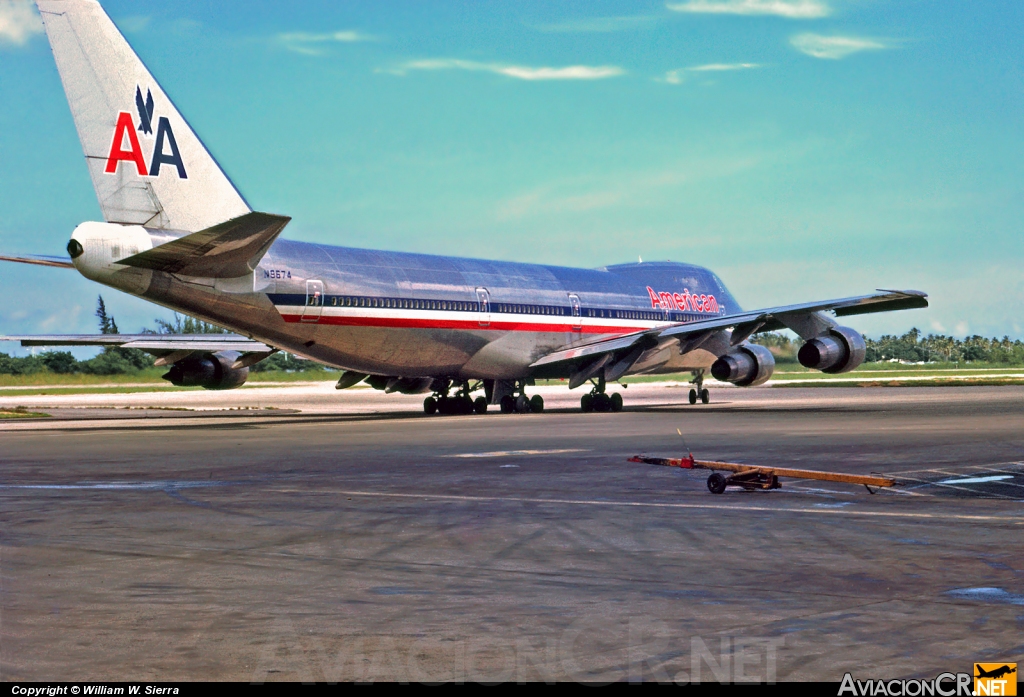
{"left": 0, "top": 296, "right": 324, "bottom": 376}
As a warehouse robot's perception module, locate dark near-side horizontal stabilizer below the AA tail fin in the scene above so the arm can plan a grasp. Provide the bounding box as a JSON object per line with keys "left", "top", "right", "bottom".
{"left": 118, "top": 213, "right": 291, "bottom": 278}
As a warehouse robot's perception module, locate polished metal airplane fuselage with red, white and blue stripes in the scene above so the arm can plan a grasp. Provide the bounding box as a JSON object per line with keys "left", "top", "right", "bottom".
{"left": 96, "top": 236, "right": 739, "bottom": 380}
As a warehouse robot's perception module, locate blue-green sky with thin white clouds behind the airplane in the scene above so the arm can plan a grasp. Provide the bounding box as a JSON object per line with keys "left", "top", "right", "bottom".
{"left": 0, "top": 0, "right": 1024, "bottom": 351}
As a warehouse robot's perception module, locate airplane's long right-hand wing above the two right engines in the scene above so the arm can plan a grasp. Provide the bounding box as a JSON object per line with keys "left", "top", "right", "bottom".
{"left": 530, "top": 291, "right": 928, "bottom": 367}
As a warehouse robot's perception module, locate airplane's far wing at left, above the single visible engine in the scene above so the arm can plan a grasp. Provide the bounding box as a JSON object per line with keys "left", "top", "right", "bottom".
{"left": 0, "top": 334, "right": 274, "bottom": 356}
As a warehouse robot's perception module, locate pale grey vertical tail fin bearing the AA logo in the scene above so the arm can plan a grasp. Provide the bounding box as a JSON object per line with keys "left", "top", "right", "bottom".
{"left": 36, "top": 0, "right": 251, "bottom": 232}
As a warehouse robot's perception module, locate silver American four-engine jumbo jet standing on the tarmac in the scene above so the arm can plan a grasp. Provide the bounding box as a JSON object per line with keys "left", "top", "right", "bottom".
{"left": 0, "top": 0, "right": 928, "bottom": 415}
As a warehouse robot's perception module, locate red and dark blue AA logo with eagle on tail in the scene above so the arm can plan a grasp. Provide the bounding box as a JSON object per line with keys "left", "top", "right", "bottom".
{"left": 103, "top": 86, "right": 188, "bottom": 179}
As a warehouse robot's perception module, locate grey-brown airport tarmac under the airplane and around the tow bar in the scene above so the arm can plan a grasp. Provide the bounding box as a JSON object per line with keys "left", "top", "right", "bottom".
{"left": 0, "top": 385, "right": 1024, "bottom": 683}
